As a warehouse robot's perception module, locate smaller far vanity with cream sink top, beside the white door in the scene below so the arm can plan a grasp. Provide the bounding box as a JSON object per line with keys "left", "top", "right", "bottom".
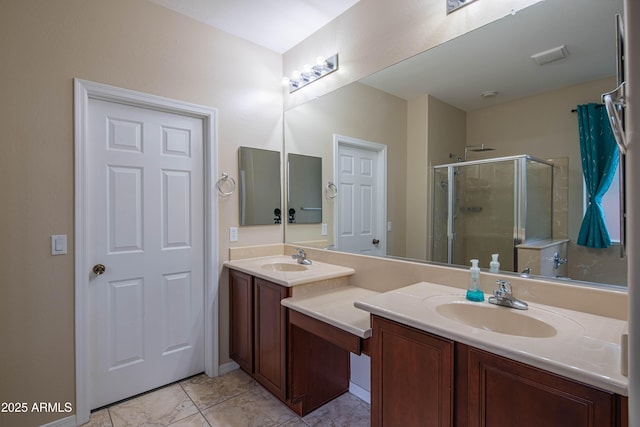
{"left": 227, "top": 257, "right": 370, "bottom": 416}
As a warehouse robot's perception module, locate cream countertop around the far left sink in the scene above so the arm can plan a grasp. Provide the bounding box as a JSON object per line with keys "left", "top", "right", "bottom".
{"left": 224, "top": 255, "right": 355, "bottom": 287}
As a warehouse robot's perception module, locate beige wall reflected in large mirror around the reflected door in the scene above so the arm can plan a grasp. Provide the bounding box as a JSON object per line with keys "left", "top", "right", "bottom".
{"left": 284, "top": 83, "right": 407, "bottom": 256}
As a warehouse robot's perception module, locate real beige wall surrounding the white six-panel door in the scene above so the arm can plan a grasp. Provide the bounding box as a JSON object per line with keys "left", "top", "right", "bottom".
{"left": 0, "top": 0, "right": 283, "bottom": 426}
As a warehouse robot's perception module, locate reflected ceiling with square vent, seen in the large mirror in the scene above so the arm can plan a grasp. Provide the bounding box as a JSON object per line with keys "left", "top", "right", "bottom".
{"left": 362, "top": 0, "right": 623, "bottom": 111}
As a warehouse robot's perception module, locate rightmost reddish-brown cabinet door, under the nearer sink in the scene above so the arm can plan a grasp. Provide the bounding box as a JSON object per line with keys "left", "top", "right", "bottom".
{"left": 458, "top": 346, "right": 616, "bottom": 427}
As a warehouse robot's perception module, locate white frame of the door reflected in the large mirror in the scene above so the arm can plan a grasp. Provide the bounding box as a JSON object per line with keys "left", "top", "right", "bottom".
{"left": 333, "top": 134, "right": 388, "bottom": 255}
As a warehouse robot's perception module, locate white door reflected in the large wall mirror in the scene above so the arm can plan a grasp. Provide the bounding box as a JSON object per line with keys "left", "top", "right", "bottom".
{"left": 334, "top": 135, "right": 386, "bottom": 255}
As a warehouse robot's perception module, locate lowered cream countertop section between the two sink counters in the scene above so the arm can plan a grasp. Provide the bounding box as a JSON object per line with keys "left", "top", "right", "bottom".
{"left": 281, "top": 286, "right": 379, "bottom": 338}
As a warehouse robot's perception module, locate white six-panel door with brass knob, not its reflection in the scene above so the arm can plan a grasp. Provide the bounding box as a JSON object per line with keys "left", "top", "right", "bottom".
{"left": 87, "top": 99, "right": 205, "bottom": 408}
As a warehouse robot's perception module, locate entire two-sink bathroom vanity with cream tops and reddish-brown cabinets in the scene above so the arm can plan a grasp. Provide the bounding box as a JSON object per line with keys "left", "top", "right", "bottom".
{"left": 226, "top": 249, "right": 628, "bottom": 427}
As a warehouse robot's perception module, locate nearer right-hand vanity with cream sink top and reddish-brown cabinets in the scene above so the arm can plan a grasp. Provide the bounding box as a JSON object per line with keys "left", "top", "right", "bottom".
{"left": 356, "top": 283, "right": 627, "bottom": 427}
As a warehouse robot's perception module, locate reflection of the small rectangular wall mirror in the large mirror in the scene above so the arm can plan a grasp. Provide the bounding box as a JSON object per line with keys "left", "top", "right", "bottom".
{"left": 287, "top": 153, "right": 322, "bottom": 224}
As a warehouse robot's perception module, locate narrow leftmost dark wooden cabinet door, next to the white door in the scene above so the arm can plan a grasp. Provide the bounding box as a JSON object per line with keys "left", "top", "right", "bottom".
{"left": 229, "top": 270, "right": 253, "bottom": 374}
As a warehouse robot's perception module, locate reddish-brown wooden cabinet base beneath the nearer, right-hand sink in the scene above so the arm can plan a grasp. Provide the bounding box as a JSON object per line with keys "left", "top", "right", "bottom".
{"left": 371, "top": 316, "right": 627, "bottom": 427}
